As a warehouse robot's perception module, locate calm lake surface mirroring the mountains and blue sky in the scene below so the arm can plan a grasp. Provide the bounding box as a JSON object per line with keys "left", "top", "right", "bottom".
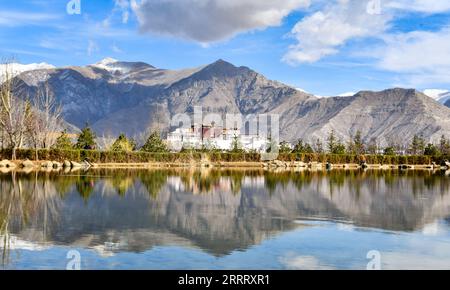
{"left": 0, "top": 170, "right": 450, "bottom": 269}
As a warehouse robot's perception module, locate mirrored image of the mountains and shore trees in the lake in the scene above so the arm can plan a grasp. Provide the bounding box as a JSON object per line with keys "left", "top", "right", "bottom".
{"left": 0, "top": 171, "right": 450, "bottom": 255}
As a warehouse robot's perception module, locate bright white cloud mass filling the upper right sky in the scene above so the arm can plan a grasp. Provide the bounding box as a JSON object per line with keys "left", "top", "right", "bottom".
{"left": 283, "top": 0, "right": 450, "bottom": 87}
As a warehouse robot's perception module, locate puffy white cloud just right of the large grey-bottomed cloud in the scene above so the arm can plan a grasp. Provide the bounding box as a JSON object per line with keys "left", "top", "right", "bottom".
{"left": 283, "top": 0, "right": 391, "bottom": 65}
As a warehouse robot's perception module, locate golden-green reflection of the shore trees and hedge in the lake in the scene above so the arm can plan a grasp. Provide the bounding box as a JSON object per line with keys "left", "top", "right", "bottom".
{"left": 52, "top": 169, "right": 450, "bottom": 200}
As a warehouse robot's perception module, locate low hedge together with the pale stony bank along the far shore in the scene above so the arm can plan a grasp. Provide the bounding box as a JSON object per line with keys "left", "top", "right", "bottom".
{"left": 0, "top": 149, "right": 450, "bottom": 169}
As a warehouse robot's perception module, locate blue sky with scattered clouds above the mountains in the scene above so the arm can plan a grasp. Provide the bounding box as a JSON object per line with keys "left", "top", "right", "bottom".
{"left": 0, "top": 0, "right": 450, "bottom": 96}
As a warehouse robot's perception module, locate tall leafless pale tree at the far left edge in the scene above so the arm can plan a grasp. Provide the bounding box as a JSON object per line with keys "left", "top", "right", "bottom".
{"left": 0, "top": 62, "right": 31, "bottom": 160}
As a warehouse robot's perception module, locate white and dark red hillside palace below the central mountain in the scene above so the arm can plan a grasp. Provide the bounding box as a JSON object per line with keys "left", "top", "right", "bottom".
{"left": 167, "top": 125, "right": 268, "bottom": 152}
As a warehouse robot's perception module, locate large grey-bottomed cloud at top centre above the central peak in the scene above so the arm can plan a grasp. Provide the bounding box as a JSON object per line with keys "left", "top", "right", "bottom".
{"left": 131, "top": 0, "right": 310, "bottom": 43}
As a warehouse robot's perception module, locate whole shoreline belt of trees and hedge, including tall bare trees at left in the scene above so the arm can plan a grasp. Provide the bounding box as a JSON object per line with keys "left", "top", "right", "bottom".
{"left": 0, "top": 63, "right": 450, "bottom": 168}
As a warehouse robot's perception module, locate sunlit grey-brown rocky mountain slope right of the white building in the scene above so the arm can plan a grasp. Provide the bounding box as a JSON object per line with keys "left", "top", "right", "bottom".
{"left": 279, "top": 89, "right": 450, "bottom": 146}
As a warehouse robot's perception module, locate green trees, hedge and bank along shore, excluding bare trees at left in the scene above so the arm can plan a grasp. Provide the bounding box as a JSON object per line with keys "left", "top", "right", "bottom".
{"left": 0, "top": 120, "right": 450, "bottom": 169}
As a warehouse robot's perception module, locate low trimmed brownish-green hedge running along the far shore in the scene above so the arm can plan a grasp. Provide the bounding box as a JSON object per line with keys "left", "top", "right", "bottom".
{"left": 0, "top": 149, "right": 442, "bottom": 165}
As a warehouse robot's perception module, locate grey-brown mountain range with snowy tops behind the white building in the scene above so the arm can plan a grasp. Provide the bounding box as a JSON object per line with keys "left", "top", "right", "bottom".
{"left": 10, "top": 58, "right": 450, "bottom": 145}
